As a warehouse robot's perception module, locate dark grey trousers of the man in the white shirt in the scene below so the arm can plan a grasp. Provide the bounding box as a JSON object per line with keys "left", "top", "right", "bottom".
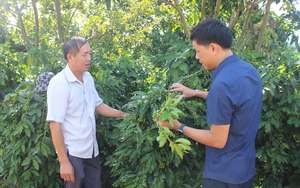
{"left": 64, "top": 155, "right": 102, "bottom": 188}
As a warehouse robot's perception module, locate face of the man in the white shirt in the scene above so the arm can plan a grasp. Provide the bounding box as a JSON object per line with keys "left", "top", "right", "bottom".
{"left": 69, "top": 43, "right": 92, "bottom": 73}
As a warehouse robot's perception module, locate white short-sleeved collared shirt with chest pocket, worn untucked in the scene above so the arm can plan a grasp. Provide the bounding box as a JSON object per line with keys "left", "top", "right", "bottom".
{"left": 47, "top": 65, "right": 103, "bottom": 158}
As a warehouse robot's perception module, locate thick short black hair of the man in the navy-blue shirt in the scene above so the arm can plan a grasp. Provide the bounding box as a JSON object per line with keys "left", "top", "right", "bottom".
{"left": 190, "top": 18, "right": 233, "bottom": 48}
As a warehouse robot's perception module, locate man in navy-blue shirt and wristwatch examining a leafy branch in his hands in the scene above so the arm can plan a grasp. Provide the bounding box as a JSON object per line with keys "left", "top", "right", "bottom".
{"left": 159, "top": 19, "right": 262, "bottom": 188}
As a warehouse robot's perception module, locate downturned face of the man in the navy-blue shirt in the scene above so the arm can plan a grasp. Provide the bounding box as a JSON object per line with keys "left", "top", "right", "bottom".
{"left": 193, "top": 40, "right": 216, "bottom": 70}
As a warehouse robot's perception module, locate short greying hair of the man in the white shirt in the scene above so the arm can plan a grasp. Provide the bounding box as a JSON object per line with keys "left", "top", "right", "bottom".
{"left": 61, "top": 37, "right": 88, "bottom": 61}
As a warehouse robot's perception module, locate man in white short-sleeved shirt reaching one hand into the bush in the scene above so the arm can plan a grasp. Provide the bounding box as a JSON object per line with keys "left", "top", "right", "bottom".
{"left": 47, "top": 37, "right": 128, "bottom": 188}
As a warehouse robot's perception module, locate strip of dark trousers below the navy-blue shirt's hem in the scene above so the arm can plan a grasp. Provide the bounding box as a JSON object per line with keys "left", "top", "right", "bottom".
{"left": 203, "top": 177, "right": 254, "bottom": 188}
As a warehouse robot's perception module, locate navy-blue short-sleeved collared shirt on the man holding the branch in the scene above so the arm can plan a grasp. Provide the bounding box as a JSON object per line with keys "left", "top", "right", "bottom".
{"left": 203, "top": 54, "right": 262, "bottom": 184}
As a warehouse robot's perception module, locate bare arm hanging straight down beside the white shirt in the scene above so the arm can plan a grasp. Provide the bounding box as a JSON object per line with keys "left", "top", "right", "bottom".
{"left": 50, "top": 121, "right": 75, "bottom": 182}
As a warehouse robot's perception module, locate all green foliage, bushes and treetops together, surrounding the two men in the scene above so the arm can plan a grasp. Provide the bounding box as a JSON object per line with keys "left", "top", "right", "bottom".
{"left": 0, "top": 0, "right": 300, "bottom": 188}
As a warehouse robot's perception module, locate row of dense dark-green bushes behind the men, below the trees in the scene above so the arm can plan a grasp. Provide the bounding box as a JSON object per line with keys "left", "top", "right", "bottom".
{"left": 0, "top": 43, "right": 300, "bottom": 188}
